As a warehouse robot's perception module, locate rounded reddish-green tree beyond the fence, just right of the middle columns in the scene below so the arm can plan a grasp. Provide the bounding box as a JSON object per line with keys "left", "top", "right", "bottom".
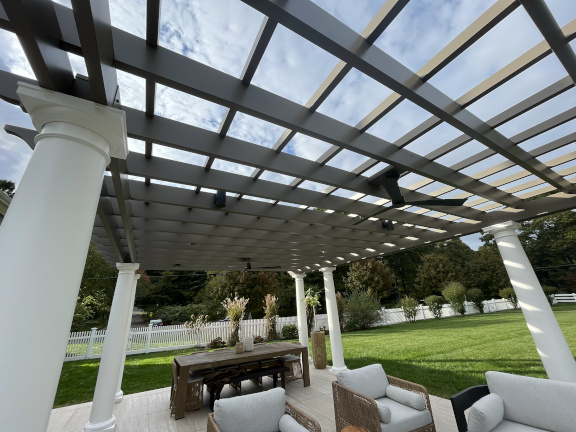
{"left": 345, "top": 258, "right": 394, "bottom": 299}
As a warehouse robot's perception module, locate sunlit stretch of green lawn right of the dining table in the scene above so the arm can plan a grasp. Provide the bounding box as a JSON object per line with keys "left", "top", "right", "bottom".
{"left": 326, "top": 303, "right": 576, "bottom": 398}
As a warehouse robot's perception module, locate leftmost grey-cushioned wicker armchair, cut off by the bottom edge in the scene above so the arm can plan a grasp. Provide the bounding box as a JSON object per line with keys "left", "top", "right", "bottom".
{"left": 206, "top": 388, "right": 321, "bottom": 432}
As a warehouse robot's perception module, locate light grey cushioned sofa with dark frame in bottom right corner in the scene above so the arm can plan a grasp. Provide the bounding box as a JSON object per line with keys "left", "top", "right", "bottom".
{"left": 450, "top": 371, "right": 576, "bottom": 432}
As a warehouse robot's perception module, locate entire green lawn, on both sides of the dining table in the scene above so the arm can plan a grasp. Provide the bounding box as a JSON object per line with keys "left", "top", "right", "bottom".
{"left": 54, "top": 303, "right": 576, "bottom": 407}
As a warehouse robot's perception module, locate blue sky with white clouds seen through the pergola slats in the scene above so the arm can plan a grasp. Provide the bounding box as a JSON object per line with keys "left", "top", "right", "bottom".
{"left": 0, "top": 0, "right": 576, "bottom": 249}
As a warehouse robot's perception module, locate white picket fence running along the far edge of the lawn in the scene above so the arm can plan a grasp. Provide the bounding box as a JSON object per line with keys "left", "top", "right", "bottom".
{"left": 64, "top": 299, "right": 512, "bottom": 361}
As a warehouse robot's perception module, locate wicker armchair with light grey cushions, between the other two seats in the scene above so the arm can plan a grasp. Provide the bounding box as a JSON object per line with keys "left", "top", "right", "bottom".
{"left": 332, "top": 364, "right": 436, "bottom": 432}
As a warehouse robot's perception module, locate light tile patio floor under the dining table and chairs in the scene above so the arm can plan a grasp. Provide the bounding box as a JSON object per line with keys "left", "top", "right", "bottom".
{"left": 48, "top": 366, "right": 457, "bottom": 432}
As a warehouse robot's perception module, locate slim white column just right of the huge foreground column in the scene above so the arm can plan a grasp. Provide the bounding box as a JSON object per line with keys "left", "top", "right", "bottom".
{"left": 84, "top": 263, "right": 139, "bottom": 432}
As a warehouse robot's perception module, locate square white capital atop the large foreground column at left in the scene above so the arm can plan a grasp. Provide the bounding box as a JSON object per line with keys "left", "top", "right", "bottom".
{"left": 16, "top": 82, "right": 128, "bottom": 159}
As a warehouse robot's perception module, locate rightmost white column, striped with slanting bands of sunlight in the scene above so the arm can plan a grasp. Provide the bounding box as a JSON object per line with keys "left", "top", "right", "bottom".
{"left": 484, "top": 222, "right": 576, "bottom": 383}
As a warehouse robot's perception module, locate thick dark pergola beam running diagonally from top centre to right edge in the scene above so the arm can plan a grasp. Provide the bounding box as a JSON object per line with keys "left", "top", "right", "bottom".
{"left": 243, "top": 0, "right": 572, "bottom": 192}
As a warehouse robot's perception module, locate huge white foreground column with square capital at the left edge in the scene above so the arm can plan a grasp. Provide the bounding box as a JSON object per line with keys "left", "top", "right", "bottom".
{"left": 0, "top": 83, "right": 127, "bottom": 432}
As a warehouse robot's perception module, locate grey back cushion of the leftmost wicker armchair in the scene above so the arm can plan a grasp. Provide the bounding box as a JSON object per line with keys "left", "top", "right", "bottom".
{"left": 214, "top": 388, "right": 286, "bottom": 432}
